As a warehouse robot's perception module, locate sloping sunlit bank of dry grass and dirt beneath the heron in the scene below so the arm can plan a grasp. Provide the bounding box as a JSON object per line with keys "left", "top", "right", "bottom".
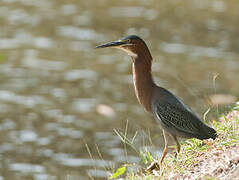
{"left": 112, "top": 104, "right": 239, "bottom": 180}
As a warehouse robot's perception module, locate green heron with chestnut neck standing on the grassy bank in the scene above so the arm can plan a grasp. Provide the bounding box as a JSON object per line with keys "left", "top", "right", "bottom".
{"left": 96, "top": 35, "right": 217, "bottom": 165}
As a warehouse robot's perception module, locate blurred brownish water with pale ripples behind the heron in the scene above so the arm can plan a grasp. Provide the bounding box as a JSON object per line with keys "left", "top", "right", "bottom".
{"left": 0, "top": 0, "right": 239, "bottom": 180}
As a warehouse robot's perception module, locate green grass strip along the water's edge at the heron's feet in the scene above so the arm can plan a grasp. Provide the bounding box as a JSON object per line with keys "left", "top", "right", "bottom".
{"left": 111, "top": 103, "right": 239, "bottom": 180}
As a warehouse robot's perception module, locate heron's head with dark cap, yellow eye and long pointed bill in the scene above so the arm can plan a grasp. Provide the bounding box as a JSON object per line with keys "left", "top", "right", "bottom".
{"left": 96, "top": 35, "right": 148, "bottom": 58}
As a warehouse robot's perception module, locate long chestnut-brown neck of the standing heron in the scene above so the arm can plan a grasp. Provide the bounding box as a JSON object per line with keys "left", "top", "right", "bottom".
{"left": 132, "top": 52, "right": 156, "bottom": 112}
